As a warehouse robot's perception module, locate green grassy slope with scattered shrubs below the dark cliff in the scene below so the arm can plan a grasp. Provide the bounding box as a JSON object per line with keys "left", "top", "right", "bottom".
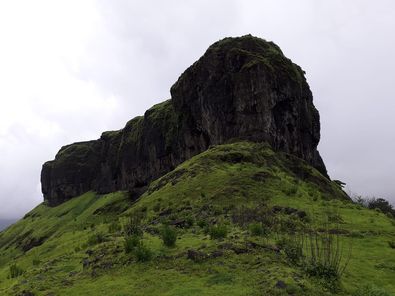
{"left": 0, "top": 142, "right": 395, "bottom": 296}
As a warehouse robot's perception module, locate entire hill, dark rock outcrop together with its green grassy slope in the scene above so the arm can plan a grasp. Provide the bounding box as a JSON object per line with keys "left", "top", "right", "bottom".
{"left": 0, "top": 36, "right": 395, "bottom": 296}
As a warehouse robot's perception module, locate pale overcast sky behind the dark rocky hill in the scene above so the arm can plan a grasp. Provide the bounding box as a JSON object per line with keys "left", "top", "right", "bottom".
{"left": 0, "top": 0, "right": 395, "bottom": 218}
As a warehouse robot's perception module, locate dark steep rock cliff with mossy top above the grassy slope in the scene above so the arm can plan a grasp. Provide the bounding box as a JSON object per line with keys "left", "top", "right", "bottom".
{"left": 41, "top": 35, "right": 326, "bottom": 206}
